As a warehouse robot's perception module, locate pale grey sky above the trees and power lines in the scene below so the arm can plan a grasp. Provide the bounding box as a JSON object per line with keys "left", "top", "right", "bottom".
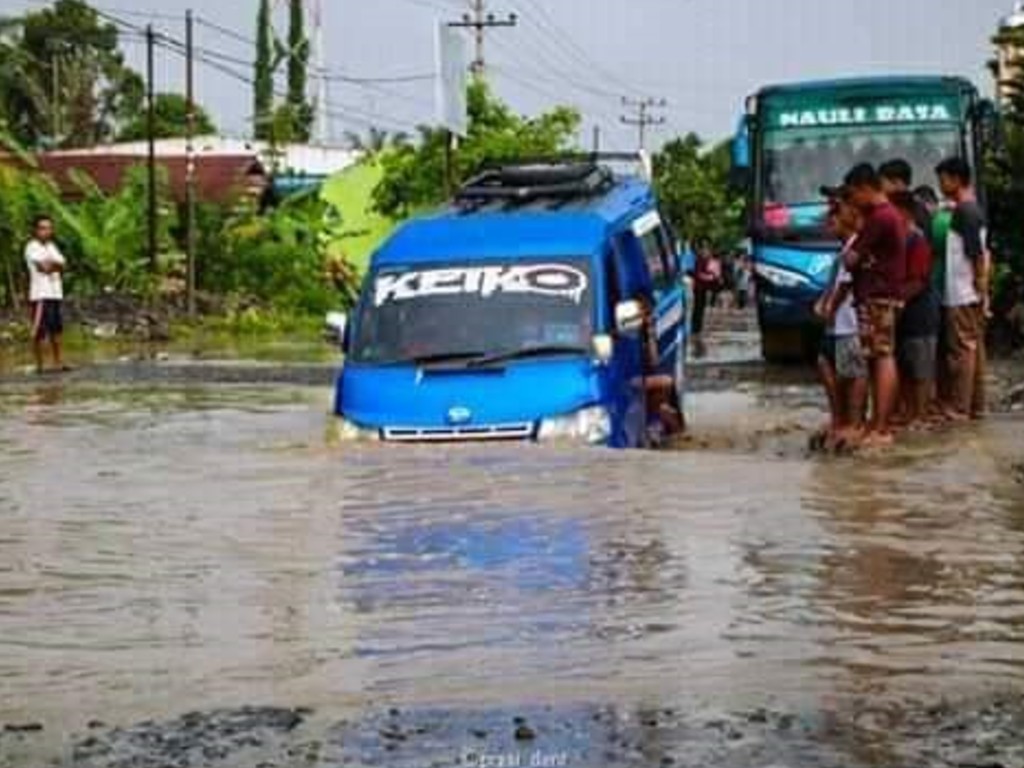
{"left": 6, "top": 0, "right": 1013, "bottom": 148}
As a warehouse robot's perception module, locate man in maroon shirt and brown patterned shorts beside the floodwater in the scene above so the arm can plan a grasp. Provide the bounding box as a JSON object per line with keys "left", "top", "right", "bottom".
{"left": 844, "top": 164, "right": 906, "bottom": 444}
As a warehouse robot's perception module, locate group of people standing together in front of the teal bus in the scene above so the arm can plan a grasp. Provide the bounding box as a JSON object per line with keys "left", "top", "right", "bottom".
{"left": 815, "top": 158, "right": 991, "bottom": 447}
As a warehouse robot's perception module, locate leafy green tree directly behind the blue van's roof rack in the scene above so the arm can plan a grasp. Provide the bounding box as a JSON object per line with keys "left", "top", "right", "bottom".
{"left": 374, "top": 82, "right": 580, "bottom": 218}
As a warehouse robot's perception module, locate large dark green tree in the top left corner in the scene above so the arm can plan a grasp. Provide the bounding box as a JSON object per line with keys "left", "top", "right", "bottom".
{"left": 6, "top": 0, "right": 144, "bottom": 147}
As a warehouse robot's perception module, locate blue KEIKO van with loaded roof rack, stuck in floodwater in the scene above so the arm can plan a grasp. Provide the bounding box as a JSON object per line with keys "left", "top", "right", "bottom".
{"left": 335, "top": 158, "right": 688, "bottom": 447}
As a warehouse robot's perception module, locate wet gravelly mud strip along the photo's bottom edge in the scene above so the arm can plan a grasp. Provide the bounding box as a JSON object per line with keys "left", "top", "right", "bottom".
{"left": 7, "top": 695, "right": 1024, "bottom": 768}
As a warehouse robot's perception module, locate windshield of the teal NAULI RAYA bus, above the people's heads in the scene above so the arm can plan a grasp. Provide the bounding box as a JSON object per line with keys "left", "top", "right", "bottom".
{"left": 762, "top": 125, "right": 962, "bottom": 228}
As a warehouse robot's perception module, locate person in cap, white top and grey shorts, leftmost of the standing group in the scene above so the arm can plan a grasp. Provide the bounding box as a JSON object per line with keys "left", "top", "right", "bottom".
{"left": 814, "top": 187, "right": 867, "bottom": 451}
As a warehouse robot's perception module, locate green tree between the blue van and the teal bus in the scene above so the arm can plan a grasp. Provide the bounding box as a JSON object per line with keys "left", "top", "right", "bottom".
{"left": 654, "top": 133, "right": 743, "bottom": 248}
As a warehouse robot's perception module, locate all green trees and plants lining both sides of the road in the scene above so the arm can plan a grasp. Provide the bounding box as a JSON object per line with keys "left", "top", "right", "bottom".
{"left": 0, "top": 0, "right": 1024, "bottom": 352}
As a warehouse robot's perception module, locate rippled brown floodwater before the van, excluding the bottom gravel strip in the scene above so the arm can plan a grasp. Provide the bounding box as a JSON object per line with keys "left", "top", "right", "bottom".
{"left": 0, "top": 388, "right": 1024, "bottom": 764}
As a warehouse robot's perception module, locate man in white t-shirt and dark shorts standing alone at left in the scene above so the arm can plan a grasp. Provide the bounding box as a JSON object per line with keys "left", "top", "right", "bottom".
{"left": 25, "top": 216, "right": 68, "bottom": 373}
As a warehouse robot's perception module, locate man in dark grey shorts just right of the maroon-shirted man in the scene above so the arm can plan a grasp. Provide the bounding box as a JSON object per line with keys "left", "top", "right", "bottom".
{"left": 889, "top": 191, "right": 941, "bottom": 424}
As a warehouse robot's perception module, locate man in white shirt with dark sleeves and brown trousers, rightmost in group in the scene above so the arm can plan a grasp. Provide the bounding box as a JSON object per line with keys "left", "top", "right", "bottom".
{"left": 935, "top": 158, "right": 990, "bottom": 419}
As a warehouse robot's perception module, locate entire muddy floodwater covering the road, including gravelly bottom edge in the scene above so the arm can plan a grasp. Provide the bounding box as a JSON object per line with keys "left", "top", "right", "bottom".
{"left": 0, "top": 313, "right": 1024, "bottom": 768}
